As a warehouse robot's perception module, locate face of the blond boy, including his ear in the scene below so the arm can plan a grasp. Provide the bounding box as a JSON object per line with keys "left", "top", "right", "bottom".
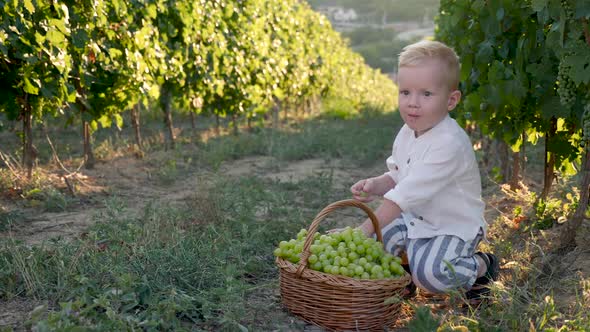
{"left": 398, "top": 59, "right": 461, "bottom": 136}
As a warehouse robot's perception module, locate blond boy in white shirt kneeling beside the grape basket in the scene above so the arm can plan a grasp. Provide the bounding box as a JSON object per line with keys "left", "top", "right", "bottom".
{"left": 350, "top": 41, "right": 499, "bottom": 302}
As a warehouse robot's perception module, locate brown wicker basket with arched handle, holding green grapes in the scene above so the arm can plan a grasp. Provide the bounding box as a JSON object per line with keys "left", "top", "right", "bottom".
{"left": 276, "top": 200, "right": 410, "bottom": 331}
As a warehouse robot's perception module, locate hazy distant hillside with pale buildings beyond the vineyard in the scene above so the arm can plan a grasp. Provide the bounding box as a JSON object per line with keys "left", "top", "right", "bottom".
{"left": 307, "top": 0, "right": 439, "bottom": 24}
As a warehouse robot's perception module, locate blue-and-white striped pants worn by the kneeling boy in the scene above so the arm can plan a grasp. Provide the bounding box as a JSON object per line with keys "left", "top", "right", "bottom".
{"left": 381, "top": 218, "right": 483, "bottom": 293}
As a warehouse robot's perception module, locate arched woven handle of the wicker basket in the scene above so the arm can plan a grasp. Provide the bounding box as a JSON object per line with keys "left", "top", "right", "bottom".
{"left": 296, "top": 199, "right": 383, "bottom": 277}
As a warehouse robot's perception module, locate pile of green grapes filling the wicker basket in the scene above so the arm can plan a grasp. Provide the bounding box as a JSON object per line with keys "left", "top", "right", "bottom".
{"left": 274, "top": 227, "right": 405, "bottom": 279}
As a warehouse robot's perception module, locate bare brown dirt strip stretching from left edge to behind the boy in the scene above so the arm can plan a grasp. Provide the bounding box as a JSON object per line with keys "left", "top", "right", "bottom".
{"left": 0, "top": 155, "right": 380, "bottom": 244}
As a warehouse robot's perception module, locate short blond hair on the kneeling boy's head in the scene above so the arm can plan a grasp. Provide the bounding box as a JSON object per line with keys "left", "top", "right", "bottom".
{"left": 398, "top": 40, "right": 461, "bottom": 90}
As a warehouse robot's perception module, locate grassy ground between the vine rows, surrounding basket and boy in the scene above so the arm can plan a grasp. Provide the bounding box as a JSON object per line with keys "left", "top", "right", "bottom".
{"left": 0, "top": 113, "right": 590, "bottom": 331}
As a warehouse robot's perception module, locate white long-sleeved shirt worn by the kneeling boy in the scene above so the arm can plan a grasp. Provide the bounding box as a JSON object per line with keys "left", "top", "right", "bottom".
{"left": 383, "top": 115, "right": 486, "bottom": 241}
